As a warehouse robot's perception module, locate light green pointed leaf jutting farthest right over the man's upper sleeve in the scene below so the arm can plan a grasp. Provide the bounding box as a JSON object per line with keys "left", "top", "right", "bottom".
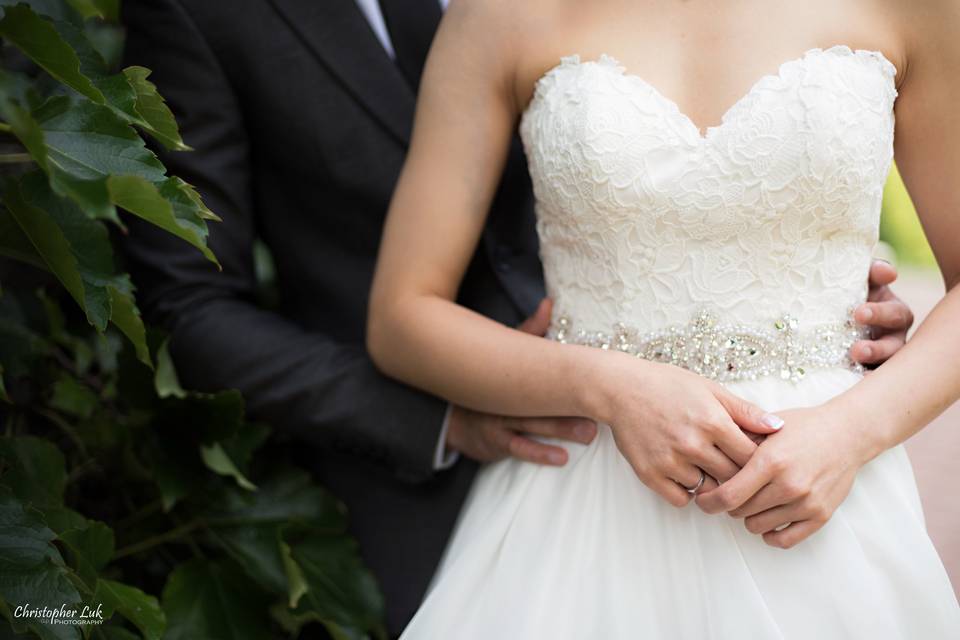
{"left": 107, "top": 175, "right": 220, "bottom": 267}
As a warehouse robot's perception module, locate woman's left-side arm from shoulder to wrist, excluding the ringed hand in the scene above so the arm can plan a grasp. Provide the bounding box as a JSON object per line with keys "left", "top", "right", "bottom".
{"left": 367, "top": 2, "right": 593, "bottom": 416}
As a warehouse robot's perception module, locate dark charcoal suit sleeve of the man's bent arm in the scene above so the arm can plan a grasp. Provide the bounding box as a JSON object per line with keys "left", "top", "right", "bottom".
{"left": 122, "top": 0, "right": 447, "bottom": 482}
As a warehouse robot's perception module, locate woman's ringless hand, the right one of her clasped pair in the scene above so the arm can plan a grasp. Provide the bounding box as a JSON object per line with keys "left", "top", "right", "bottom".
{"left": 697, "top": 405, "right": 870, "bottom": 549}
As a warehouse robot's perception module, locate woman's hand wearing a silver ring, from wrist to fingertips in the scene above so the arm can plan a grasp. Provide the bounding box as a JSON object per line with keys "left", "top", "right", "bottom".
{"left": 597, "top": 352, "right": 782, "bottom": 507}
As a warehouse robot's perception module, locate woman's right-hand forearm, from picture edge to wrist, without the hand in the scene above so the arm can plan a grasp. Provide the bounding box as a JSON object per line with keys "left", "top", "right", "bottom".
{"left": 830, "top": 286, "right": 960, "bottom": 460}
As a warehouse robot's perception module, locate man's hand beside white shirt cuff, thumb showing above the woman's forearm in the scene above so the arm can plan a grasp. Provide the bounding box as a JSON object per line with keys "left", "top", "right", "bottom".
{"left": 447, "top": 298, "right": 597, "bottom": 466}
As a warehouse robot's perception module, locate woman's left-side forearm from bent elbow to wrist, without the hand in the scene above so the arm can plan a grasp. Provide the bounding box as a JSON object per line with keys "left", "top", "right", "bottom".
{"left": 367, "top": 295, "right": 611, "bottom": 419}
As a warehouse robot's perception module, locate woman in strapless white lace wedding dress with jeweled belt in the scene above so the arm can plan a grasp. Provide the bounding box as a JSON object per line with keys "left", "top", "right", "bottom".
{"left": 368, "top": 0, "right": 960, "bottom": 640}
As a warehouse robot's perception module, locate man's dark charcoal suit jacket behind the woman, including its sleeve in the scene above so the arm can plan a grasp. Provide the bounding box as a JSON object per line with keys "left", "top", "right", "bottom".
{"left": 123, "top": 0, "right": 543, "bottom": 631}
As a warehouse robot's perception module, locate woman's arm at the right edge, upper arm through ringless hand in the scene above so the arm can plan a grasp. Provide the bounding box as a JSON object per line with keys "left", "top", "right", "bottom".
{"left": 697, "top": 0, "right": 960, "bottom": 547}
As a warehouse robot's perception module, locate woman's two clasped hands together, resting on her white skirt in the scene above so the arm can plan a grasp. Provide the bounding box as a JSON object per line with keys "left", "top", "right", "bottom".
{"left": 580, "top": 352, "right": 879, "bottom": 548}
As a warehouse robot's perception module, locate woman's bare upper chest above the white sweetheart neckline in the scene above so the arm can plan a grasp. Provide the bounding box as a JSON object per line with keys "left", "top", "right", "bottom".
{"left": 514, "top": 0, "right": 904, "bottom": 115}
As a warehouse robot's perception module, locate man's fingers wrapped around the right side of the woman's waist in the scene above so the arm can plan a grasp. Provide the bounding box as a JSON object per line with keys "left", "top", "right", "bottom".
{"left": 850, "top": 260, "right": 913, "bottom": 365}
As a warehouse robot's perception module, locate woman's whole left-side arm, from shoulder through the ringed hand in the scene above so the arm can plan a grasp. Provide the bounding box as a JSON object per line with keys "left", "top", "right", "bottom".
{"left": 367, "top": 0, "right": 777, "bottom": 506}
